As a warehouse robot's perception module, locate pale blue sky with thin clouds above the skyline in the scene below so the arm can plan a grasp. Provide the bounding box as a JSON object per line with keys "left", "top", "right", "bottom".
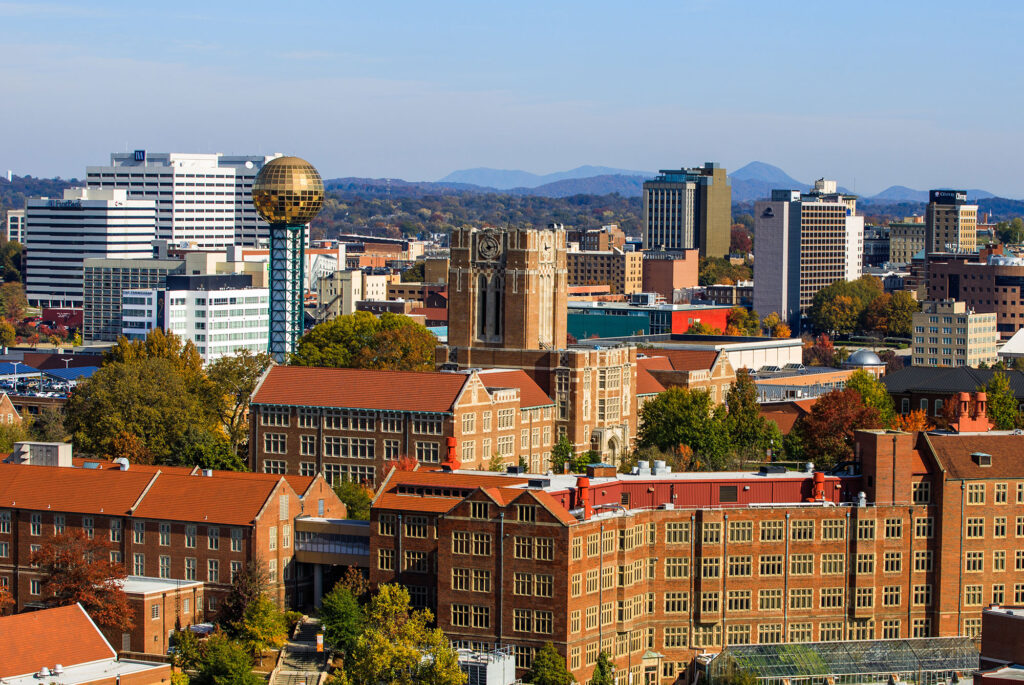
{"left": 0, "top": 0, "right": 1024, "bottom": 198}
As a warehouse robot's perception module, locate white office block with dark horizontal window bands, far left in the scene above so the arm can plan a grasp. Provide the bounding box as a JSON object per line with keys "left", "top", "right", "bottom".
{"left": 25, "top": 188, "right": 157, "bottom": 307}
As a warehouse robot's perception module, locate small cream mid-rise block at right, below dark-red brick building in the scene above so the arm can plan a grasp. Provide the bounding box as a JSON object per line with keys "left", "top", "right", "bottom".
{"left": 912, "top": 300, "right": 999, "bottom": 367}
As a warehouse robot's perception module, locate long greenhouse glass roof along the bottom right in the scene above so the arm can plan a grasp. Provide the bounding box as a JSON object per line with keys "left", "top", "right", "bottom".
{"left": 708, "top": 637, "right": 978, "bottom": 682}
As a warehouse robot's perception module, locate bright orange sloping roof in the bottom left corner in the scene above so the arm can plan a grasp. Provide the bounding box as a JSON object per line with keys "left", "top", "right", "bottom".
{"left": 0, "top": 604, "right": 117, "bottom": 682}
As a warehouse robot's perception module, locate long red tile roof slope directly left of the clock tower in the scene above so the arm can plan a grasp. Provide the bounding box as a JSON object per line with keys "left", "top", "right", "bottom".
{"left": 253, "top": 367, "right": 468, "bottom": 412}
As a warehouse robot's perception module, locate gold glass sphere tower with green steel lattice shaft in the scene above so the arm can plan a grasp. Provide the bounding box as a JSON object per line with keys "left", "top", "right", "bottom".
{"left": 253, "top": 157, "right": 324, "bottom": 363}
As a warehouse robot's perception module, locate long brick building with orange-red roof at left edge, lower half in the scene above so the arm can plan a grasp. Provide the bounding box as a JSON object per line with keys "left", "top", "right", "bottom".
{"left": 0, "top": 453, "right": 345, "bottom": 615}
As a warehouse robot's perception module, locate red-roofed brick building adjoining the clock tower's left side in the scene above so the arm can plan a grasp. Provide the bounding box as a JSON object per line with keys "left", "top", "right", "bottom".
{"left": 249, "top": 367, "right": 557, "bottom": 484}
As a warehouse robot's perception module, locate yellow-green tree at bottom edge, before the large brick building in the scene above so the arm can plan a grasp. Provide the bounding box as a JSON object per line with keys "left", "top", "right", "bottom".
{"left": 345, "top": 585, "right": 466, "bottom": 685}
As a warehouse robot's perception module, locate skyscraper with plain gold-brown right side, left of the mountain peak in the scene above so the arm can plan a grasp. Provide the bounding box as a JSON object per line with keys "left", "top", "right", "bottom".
{"left": 643, "top": 162, "right": 732, "bottom": 257}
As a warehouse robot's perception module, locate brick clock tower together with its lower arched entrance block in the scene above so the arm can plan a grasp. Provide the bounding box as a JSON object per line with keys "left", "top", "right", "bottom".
{"left": 436, "top": 227, "right": 636, "bottom": 463}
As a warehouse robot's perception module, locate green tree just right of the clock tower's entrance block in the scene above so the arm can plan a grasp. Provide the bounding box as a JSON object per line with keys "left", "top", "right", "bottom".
{"left": 638, "top": 387, "right": 727, "bottom": 471}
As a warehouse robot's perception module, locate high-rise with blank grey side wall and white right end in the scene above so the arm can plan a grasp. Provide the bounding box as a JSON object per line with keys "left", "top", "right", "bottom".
{"left": 754, "top": 179, "right": 864, "bottom": 333}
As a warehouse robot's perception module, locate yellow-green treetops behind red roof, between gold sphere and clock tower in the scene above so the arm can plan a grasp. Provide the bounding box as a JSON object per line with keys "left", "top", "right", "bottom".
{"left": 291, "top": 311, "right": 437, "bottom": 371}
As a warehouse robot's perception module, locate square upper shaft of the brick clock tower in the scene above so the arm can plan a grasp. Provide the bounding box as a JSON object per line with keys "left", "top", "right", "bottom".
{"left": 449, "top": 228, "right": 568, "bottom": 349}
